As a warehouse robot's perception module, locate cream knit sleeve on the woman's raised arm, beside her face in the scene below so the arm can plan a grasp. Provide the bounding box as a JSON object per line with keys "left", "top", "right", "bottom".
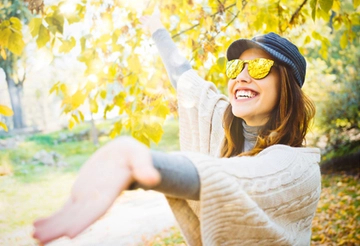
{"left": 177, "top": 69, "right": 229, "bottom": 156}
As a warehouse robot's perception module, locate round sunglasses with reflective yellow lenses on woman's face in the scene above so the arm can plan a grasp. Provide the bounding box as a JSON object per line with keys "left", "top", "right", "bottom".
{"left": 226, "top": 58, "right": 274, "bottom": 79}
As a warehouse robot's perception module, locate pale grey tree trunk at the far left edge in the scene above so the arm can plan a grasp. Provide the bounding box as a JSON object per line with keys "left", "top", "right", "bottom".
{"left": 6, "top": 76, "right": 25, "bottom": 129}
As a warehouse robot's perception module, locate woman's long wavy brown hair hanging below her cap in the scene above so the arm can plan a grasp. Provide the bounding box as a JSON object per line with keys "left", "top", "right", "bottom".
{"left": 221, "top": 65, "right": 315, "bottom": 157}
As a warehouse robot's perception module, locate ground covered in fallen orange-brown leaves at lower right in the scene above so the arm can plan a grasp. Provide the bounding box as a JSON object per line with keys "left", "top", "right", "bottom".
{"left": 312, "top": 175, "right": 360, "bottom": 245}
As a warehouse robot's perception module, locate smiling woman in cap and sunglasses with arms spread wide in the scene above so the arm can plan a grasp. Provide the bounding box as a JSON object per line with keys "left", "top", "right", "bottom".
{"left": 34, "top": 15, "right": 320, "bottom": 245}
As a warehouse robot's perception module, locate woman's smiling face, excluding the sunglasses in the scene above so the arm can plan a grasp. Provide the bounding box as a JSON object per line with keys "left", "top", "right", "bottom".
{"left": 228, "top": 48, "right": 280, "bottom": 126}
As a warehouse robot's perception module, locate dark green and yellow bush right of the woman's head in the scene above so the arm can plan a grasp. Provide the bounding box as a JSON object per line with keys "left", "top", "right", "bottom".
{"left": 305, "top": 23, "right": 360, "bottom": 156}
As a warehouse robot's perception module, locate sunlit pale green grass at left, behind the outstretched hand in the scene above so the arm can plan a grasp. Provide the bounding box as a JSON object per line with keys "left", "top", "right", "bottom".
{"left": 0, "top": 120, "right": 179, "bottom": 237}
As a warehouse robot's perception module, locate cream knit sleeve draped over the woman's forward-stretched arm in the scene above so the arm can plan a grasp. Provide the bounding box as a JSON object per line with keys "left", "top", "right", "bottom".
{"left": 177, "top": 145, "right": 320, "bottom": 245}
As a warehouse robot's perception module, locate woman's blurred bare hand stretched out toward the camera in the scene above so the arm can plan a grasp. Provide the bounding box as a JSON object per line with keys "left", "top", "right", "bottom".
{"left": 33, "top": 137, "right": 160, "bottom": 244}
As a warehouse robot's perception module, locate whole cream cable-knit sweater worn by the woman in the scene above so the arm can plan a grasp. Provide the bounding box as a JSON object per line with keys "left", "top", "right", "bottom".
{"left": 168, "top": 70, "right": 321, "bottom": 246}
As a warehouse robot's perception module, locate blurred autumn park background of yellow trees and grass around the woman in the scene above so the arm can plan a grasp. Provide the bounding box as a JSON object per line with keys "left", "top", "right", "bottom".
{"left": 0, "top": 0, "right": 360, "bottom": 245}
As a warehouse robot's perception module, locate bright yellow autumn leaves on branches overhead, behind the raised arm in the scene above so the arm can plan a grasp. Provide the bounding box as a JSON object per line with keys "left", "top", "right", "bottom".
{"left": 2, "top": 0, "right": 359, "bottom": 145}
